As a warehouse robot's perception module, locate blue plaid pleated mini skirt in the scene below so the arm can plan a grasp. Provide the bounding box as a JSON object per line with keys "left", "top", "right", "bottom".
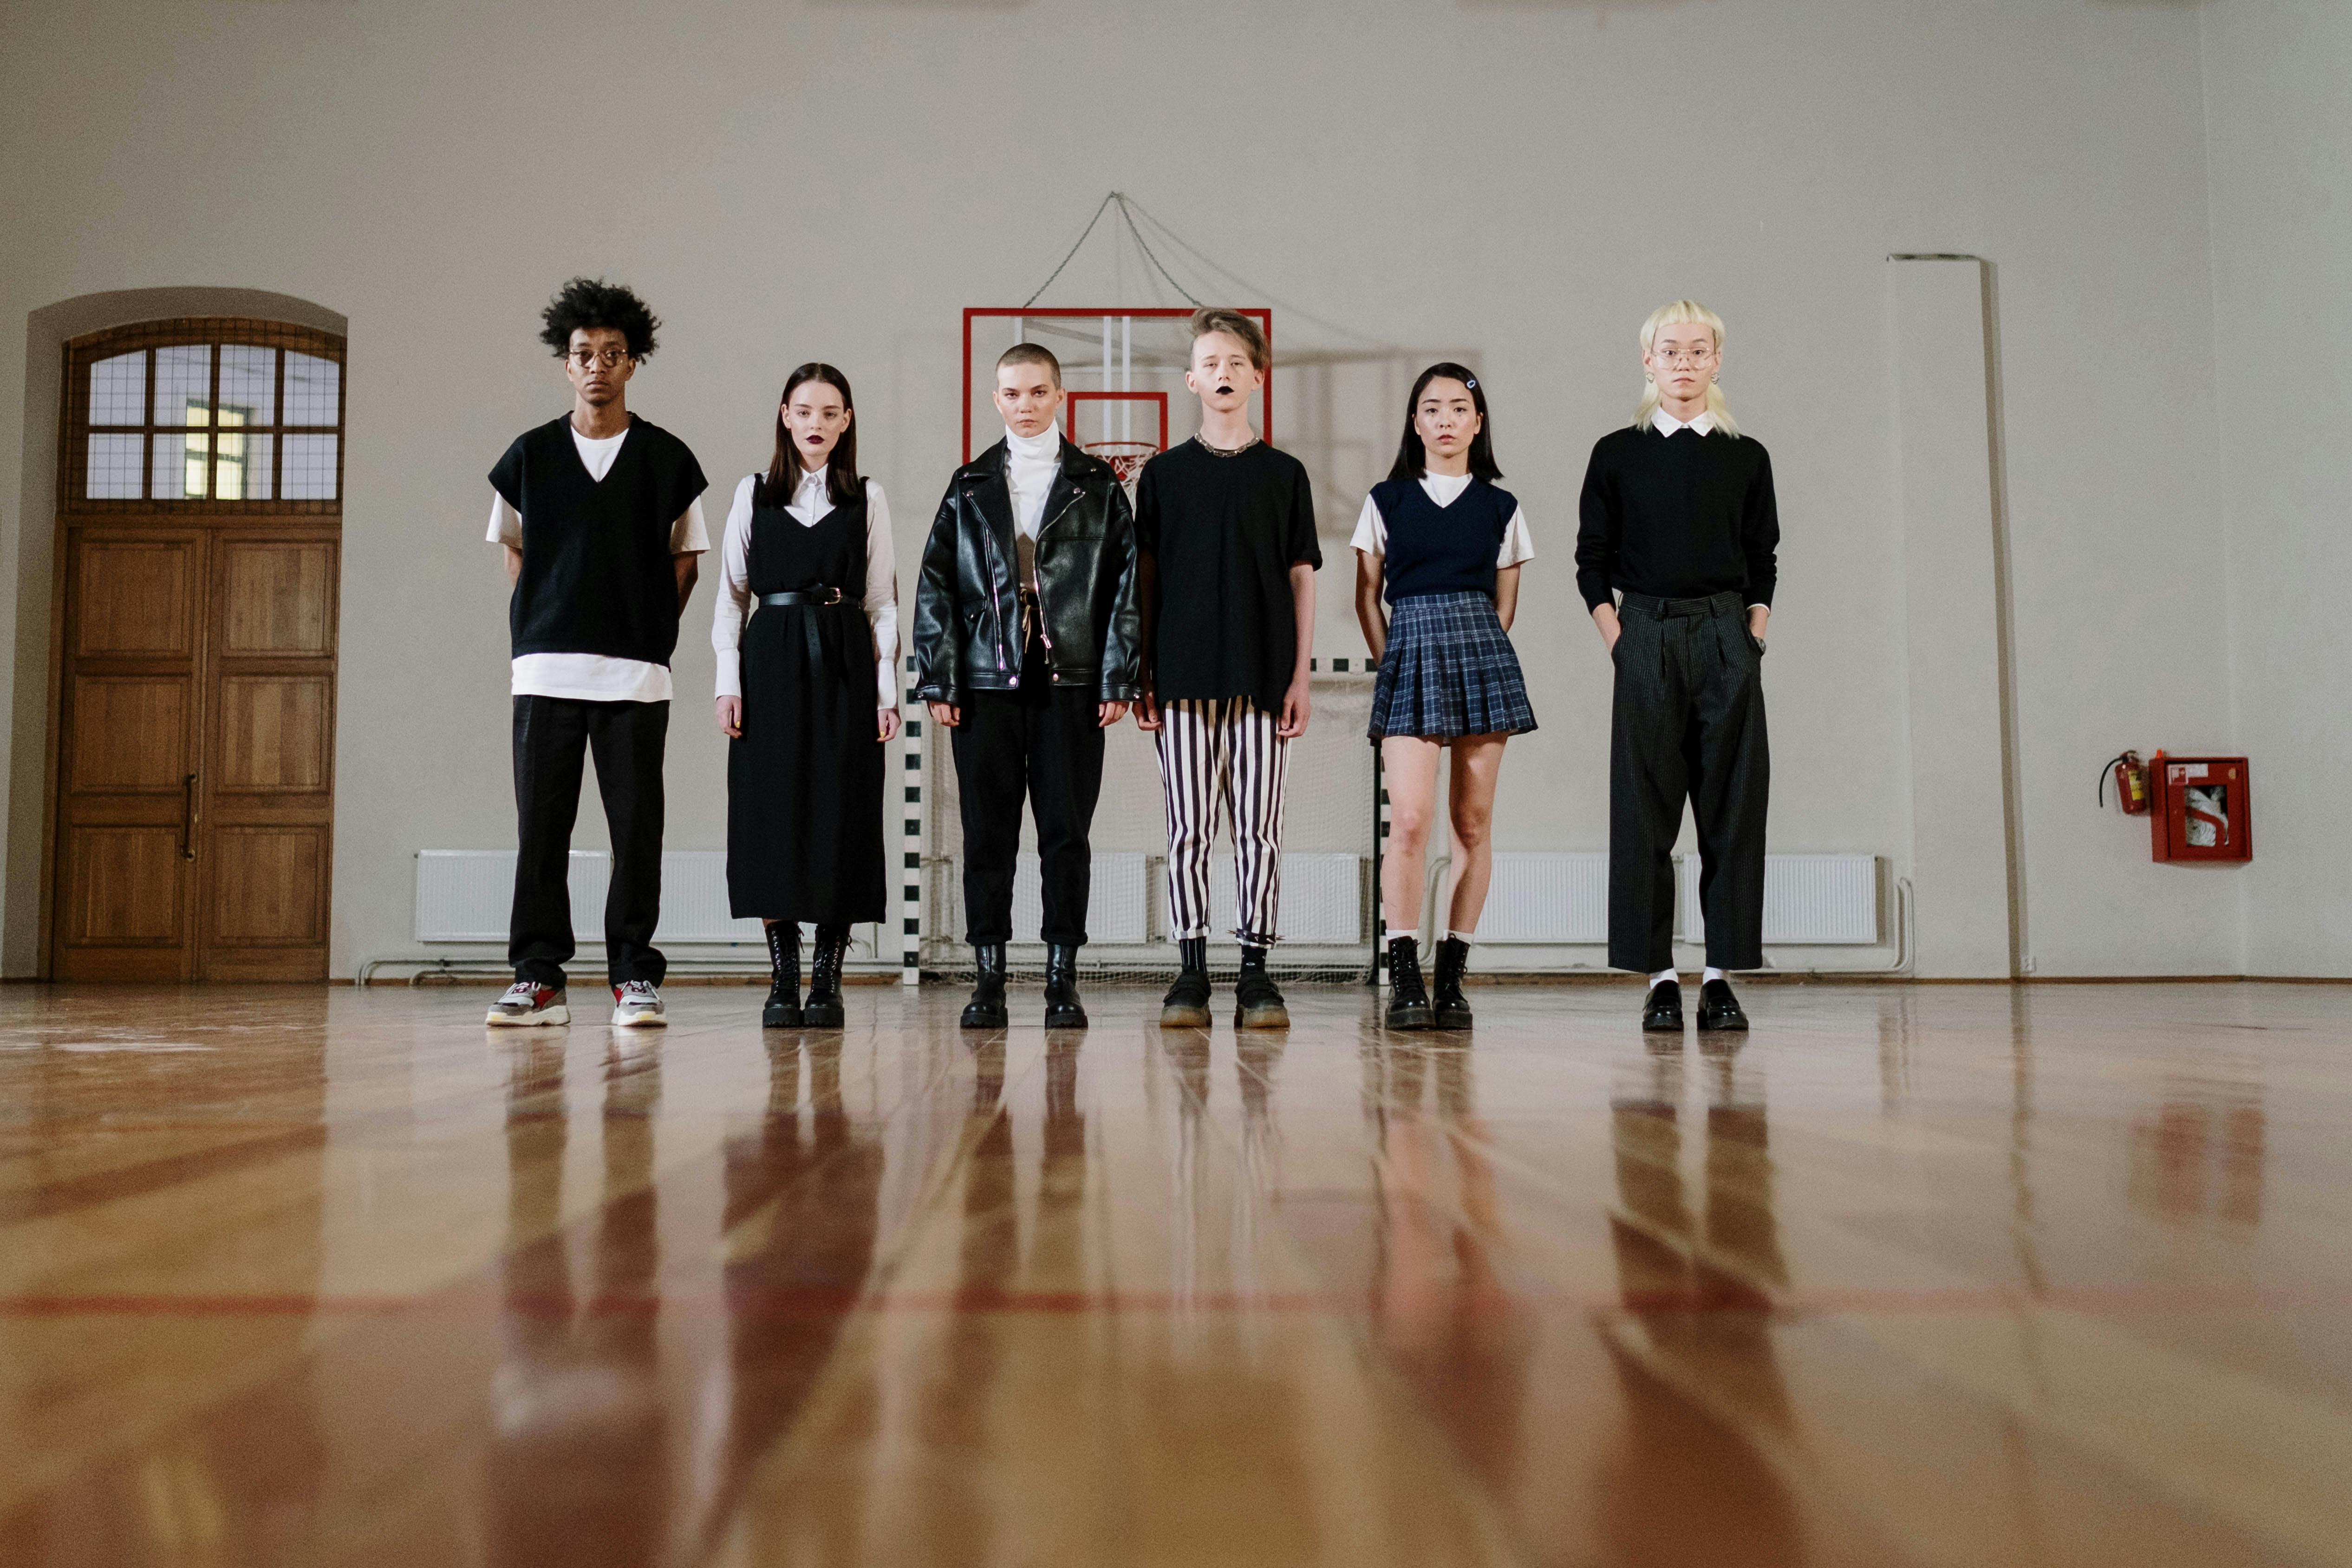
{"left": 1369, "top": 592, "right": 1536, "bottom": 741}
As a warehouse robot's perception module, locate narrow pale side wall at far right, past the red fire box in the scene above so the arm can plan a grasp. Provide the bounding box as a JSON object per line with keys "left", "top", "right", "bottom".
{"left": 2204, "top": 0, "right": 2352, "bottom": 976}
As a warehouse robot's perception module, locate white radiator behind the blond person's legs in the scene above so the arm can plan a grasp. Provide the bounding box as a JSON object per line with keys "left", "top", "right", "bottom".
{"left": 1477, "top": 849, "right": 1879, "bottom": 947}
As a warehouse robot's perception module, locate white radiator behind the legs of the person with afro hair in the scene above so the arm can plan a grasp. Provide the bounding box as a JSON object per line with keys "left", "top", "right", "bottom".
{"left": 417, "top": 849, "right": 762, "bottom": 945}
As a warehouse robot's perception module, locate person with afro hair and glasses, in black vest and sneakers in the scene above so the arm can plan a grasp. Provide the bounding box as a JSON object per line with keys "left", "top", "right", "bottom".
{"left": 489, "top": 277, "right": 710, "bottom": 1025}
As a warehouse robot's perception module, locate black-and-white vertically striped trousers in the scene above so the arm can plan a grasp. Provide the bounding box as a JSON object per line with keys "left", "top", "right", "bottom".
{"left": 1160, "top": 696, "right": 1291, "bottom": 947}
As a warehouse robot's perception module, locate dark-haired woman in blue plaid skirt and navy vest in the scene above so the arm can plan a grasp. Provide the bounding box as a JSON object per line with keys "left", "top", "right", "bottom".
{"left": 1352, "top": 362, "right": 1536, "bottom": 1030}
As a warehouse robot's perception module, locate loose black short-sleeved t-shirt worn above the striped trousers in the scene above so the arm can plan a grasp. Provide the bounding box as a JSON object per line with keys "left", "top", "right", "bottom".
{"left": 1136, "top": 440, "right": 1322, "bottom": 712}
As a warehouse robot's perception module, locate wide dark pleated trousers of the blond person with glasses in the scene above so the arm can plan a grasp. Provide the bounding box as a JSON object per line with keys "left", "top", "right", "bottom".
{"left": 1609, "top": 592, "right": 1771, "bottom": 973}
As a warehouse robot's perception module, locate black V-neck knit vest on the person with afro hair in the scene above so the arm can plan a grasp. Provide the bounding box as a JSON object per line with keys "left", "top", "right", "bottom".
{"left": 489, "top": 416, "right": 706, "bottom": 665}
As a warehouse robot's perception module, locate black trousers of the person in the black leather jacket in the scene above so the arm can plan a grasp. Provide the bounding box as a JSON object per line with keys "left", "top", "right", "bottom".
{"left": 948, "top": 639, "right": 1103, "bottom": 947}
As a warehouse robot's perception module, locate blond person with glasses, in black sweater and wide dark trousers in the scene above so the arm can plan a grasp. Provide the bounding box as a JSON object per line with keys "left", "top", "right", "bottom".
{"left": 1576, "top": 299, "right": 1780, "bottom": 1032}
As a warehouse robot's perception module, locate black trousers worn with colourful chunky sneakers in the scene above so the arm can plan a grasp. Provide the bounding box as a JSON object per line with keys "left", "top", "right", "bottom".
{"left": 506, "top": 696, "right": 671, "bottom": 985}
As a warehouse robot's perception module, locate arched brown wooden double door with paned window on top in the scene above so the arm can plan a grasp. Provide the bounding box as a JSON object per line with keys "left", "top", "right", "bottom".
{"left": 49, "top": 318, "right": 343, "bottom": 980}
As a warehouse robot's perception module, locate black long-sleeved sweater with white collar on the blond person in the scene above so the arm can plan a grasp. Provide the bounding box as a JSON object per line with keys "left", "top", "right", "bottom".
{"left": 1576, "top": 425, "right": 1780, "bottom": 611}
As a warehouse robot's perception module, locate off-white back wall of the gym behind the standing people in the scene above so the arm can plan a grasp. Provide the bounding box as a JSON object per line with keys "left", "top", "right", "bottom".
{"left": 0, "top": 0, "right": 2239, "bottom": 973}
